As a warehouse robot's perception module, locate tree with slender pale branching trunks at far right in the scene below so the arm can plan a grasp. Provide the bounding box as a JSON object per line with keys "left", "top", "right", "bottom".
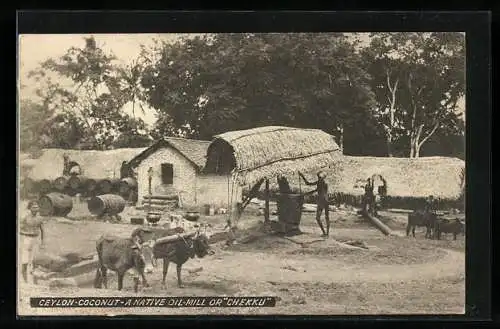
{"left": 363, "top": 32, "right": 465, "bottom": 158}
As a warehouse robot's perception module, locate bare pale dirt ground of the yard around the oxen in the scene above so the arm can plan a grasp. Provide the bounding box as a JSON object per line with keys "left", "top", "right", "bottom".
{"left": 20, "top": 202, "right": 465, "bottom": 315}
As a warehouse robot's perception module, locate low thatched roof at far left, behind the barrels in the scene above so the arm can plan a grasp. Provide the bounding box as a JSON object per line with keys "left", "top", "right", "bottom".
{"left": 28, "top": 148, "right": 145, "bottom": 180}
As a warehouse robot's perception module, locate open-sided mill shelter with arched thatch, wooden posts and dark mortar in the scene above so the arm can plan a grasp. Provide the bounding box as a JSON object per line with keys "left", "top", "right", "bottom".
{"left": 205, "top": 126, "right": 342, "bottom": 234}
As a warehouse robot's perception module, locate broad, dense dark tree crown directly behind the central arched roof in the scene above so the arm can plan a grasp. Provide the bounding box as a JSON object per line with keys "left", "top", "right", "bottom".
{"left": 142, "top": 33, "right": 373, "bottom": 145}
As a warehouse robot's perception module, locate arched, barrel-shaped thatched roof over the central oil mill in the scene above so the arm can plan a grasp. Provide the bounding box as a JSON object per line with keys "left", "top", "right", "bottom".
{"left": 206, "top": 126, "right": 341, "bottom": 184}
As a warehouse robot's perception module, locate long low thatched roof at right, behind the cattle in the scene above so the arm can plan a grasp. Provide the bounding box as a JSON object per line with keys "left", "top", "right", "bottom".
{"left": 271, "top": 156, "right": 465, "bottom": 199}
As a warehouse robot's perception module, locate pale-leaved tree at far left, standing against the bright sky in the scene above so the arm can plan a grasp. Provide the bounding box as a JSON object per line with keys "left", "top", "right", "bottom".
{"left": 27, "top": 37, "right": 148, "bottom": 149}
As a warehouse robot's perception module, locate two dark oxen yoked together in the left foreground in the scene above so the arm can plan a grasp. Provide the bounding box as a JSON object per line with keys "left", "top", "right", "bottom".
{"left": 94, "top": 227, "right": 214, "bottom": 292}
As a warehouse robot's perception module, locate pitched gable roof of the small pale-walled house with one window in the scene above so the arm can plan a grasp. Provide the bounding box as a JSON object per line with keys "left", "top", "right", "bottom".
{"left": 130, "top": 137, "right": 210, "bottom": 170}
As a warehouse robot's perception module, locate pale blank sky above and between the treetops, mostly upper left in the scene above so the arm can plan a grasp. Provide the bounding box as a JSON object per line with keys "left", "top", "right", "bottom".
{"left": 18, "top": 34, "right": 465, "bottom": 125}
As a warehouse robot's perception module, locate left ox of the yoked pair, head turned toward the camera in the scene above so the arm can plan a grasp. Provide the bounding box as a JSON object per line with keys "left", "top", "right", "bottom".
{"left": 94, "top": 236, "right": 156, "bottom": 292}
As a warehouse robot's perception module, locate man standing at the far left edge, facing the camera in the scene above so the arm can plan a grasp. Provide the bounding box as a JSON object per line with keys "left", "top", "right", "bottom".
{"left": 19, "top": 201, "right": 44, "bottom": 283}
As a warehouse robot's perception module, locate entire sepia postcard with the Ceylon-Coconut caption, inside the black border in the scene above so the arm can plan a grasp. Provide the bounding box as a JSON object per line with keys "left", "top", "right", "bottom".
{"left": 17, "top": 31, "right": 466, "bottom": 316}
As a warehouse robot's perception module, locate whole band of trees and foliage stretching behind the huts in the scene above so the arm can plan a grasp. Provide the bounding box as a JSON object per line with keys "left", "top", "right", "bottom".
{"left": 19, "top": 32, "right": 465, "bottom": 158}
